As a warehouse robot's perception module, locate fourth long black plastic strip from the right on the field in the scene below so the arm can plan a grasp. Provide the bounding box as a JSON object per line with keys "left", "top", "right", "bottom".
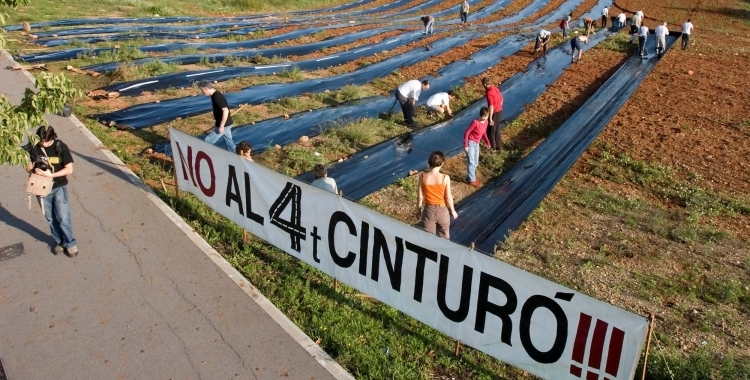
{"left": 92, "top": 33, "right": 473, "bottom": 129}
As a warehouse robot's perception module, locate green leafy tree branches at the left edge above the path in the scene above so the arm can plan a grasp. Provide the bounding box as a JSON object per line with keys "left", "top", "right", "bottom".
{"left": 0, "top": 0, "right": 83, "bottom": 165}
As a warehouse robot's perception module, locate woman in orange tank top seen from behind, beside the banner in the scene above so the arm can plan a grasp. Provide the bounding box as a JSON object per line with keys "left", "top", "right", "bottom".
{"left": 417, "top": 150, "right": 458, "bottom": 240}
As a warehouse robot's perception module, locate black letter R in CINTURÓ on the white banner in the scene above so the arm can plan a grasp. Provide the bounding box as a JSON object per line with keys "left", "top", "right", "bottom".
{"left": 474, "top": 272, "right": 518, "bottom": 346}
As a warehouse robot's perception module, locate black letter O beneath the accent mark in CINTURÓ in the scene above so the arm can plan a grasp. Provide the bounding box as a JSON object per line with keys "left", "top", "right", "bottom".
{"left": 519, "top": 295, "right": 568, "bottom": 364}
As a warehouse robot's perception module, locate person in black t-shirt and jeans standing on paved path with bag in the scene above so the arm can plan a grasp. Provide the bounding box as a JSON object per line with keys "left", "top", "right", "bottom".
{"left": 26, "top": 126, "right": 78, "bottom": 257}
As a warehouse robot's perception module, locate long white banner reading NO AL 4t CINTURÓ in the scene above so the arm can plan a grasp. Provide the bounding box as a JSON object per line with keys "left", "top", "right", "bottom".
{"left": 170, "top": 129, "right": 648, "bottom": 380}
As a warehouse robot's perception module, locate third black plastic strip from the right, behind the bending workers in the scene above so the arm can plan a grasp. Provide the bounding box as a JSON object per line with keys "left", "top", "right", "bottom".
{"left": 154, "top": 0, "right": 611, "bottom": 155}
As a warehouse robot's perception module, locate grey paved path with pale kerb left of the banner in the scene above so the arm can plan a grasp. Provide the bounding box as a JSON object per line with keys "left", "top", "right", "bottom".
{"left": 0, "top": 53, "right": 351, "bottom": 380}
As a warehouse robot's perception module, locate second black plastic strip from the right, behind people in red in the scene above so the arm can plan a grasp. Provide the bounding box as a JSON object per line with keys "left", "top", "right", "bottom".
{"left": 298, "top": 15, "right": 609, "bottom": 200}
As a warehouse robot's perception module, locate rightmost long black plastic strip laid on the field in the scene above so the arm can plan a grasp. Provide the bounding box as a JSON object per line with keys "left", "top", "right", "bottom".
{"left": 452, "top": 33, "right": 680, "bottom": 254}
